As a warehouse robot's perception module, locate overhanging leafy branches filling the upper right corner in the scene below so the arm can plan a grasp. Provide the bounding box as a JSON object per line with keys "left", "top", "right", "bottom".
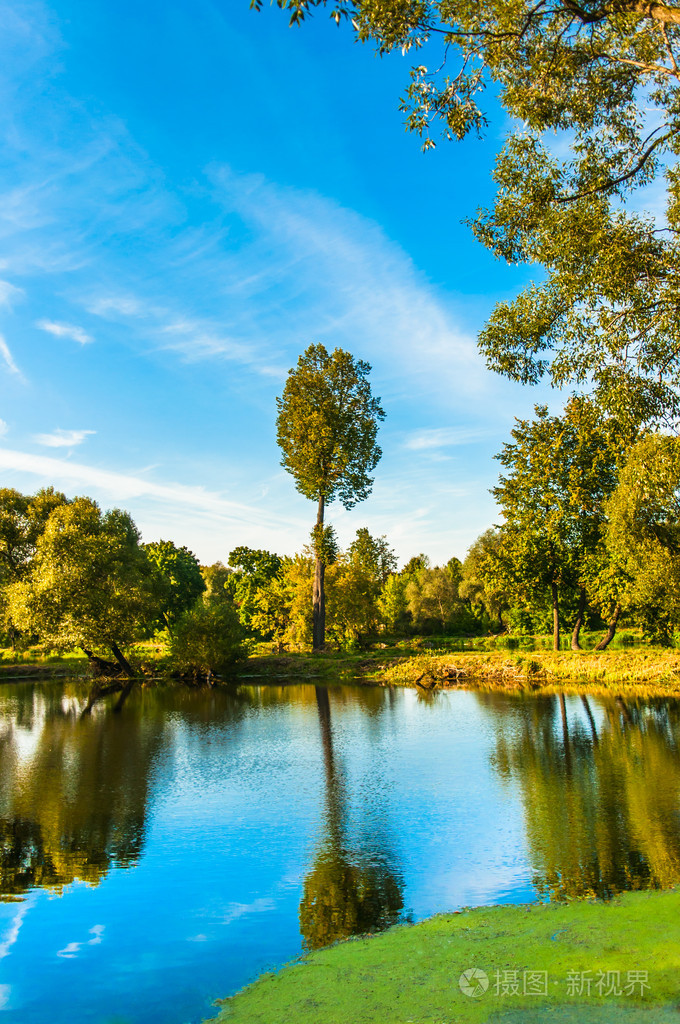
{"left": 259, "top": 0, "right": 680, "bottom": 421}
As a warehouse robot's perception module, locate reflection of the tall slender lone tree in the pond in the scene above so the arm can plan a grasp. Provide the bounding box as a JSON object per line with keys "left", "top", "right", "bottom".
{"left": 300, "top": 686, "right": 403, "bottom": 949}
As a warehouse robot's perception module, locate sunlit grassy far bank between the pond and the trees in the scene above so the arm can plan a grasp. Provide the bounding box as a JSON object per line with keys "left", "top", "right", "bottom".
{"left": 0, "top": 637, "right": 680, "bottom": 696}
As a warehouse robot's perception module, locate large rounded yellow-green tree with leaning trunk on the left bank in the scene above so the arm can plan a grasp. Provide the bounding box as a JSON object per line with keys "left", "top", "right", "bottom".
{"left": 9, "top": 498, "right": 157, "bottom": 659}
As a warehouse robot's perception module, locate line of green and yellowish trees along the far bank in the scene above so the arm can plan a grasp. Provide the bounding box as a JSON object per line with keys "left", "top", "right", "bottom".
{"left": 0, "top": 398, "right": 680, "bottom": 673}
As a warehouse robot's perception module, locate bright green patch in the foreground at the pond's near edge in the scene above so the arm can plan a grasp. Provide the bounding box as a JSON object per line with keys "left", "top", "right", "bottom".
{"left": 205, "top": 891, "right": 680, "bottom": 1024}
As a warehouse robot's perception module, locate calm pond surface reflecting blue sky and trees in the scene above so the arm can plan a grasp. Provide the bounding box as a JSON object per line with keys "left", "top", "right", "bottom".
{"left": 0, "top": 683, "right": 680, "bottom": 1024}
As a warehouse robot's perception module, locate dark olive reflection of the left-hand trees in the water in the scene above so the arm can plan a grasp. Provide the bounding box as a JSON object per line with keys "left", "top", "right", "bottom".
{"left": 0, "top": 686, "right": 158, "bottom": 900}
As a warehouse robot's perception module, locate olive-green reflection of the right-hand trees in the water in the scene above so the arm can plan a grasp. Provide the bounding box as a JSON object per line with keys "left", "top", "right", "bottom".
{"left": 479, "top": 694, "right": 680, "bottom": 899}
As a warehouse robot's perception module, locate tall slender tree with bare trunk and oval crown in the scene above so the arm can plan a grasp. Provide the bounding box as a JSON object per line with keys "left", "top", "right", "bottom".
{"left": 277, "top": 345, "right": 385, "bottom": 650}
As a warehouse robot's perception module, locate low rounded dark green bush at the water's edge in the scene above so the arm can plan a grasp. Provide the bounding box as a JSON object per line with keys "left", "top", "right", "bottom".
{"left": 170, "top": 600, "right": 246, "bottom": 675}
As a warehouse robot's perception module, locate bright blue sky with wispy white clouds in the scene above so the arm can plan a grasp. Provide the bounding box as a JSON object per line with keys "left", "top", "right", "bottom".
{"left": 0, "top": 0, "right": 558, "bottom": 562}
